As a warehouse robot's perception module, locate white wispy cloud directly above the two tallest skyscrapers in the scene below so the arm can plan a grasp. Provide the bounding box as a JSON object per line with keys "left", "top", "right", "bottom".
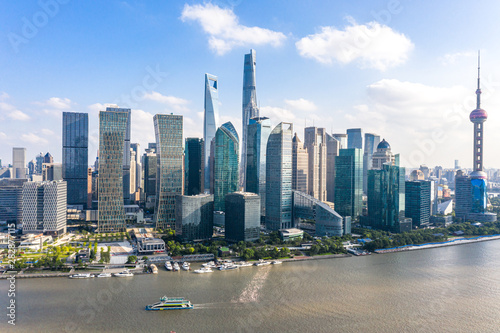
{"left": 181, "top": 3, "right": 286, "bottom": 55}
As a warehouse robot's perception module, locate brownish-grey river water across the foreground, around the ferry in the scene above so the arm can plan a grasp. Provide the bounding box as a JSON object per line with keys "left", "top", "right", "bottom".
{"left": 0, "top": 240, "right": 500, "bottom": 333}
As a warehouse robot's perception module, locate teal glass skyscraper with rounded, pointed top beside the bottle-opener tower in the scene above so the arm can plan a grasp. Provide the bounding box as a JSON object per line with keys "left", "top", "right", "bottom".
{"left": 214, "top": 122, "right": 240, "bottom": 211}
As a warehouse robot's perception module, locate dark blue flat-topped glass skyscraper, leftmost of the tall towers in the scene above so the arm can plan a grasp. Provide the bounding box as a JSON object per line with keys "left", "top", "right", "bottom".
{"left": 62, "top": 112, "right": 90, "bottom": 208}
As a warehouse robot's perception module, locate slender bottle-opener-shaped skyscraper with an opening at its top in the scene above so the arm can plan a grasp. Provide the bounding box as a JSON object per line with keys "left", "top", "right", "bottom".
{"left": 203, "top": 74, "right": 219, "bottom": 190}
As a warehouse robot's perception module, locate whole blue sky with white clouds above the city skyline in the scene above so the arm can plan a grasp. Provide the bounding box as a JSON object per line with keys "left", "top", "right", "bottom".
{"left": 0, "top": 0, "right": 500, "bottom": 168}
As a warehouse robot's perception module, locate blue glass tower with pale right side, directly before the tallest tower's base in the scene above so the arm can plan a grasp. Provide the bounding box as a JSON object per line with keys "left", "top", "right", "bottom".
{"left": 246, "top": 117, "right": 271, "bottom": 216}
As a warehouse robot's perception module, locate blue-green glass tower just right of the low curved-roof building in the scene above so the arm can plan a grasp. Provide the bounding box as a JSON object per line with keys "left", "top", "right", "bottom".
{"left": 334, "top": 149, "right": 363, "bottom": 219}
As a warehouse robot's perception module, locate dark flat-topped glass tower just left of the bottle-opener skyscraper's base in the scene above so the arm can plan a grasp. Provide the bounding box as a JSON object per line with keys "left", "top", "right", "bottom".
{"left": 184, "top": 138, "right": 205, "bottom": 195}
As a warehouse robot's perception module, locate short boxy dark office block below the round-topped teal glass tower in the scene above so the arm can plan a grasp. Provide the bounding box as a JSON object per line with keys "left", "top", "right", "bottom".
{"left": 225, "top": 192, "right": 260, "bottom": 243}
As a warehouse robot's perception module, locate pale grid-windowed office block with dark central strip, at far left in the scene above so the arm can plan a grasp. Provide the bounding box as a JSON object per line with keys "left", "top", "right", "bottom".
{"left": 22, "top": 180, "right": 67, "bottom": 236}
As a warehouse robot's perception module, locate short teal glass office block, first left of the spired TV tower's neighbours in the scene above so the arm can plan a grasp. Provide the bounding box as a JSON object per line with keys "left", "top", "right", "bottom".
{"left": 405, "top": 181, "right": 431, "bottom": 228}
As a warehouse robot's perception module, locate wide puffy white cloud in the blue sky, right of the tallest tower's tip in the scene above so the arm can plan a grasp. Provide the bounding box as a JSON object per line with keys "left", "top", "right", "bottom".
{"left": 295, "top": 18, "right": 414, "bottom": 71}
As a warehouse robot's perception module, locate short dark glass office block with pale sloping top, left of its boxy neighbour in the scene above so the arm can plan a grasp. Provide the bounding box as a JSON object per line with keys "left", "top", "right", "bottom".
{"left": 175, "top": 194, "right": 214, "bottom": 242}
